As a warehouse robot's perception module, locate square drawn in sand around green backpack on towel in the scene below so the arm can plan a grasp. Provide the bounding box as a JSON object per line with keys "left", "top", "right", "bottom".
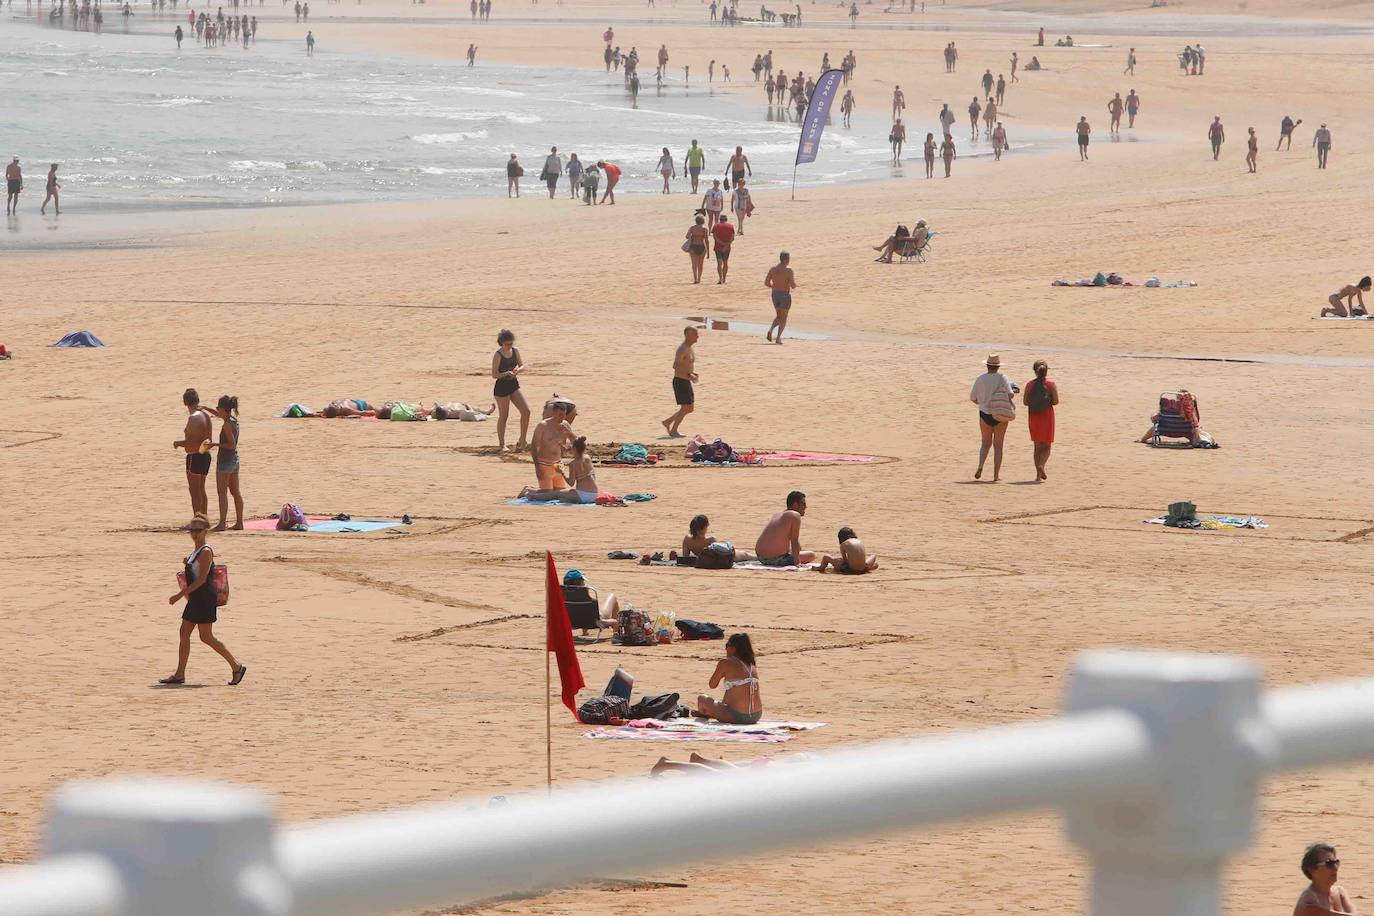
{"left": 985, "top": 505, "right": 1374, "bottom": 544}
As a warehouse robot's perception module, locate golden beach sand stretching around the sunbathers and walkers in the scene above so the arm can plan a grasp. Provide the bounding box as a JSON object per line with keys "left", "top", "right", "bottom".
{"left": 0, "top": 4, "right": 1374, "bottom": 915}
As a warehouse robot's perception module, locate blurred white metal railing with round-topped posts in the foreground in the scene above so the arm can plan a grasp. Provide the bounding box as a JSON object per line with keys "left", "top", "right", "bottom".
{"left": 0, "top": 651, "right": 1374, "bottom": 916}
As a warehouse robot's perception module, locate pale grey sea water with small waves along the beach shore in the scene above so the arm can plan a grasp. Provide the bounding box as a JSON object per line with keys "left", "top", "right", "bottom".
{"left": 0, "top": 19, "right": 1055, "bottom": 209}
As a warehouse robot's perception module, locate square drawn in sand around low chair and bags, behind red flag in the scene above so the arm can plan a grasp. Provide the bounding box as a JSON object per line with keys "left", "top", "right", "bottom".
{"left": 398, "top": 614, "right": 910, "bottom": 659}
